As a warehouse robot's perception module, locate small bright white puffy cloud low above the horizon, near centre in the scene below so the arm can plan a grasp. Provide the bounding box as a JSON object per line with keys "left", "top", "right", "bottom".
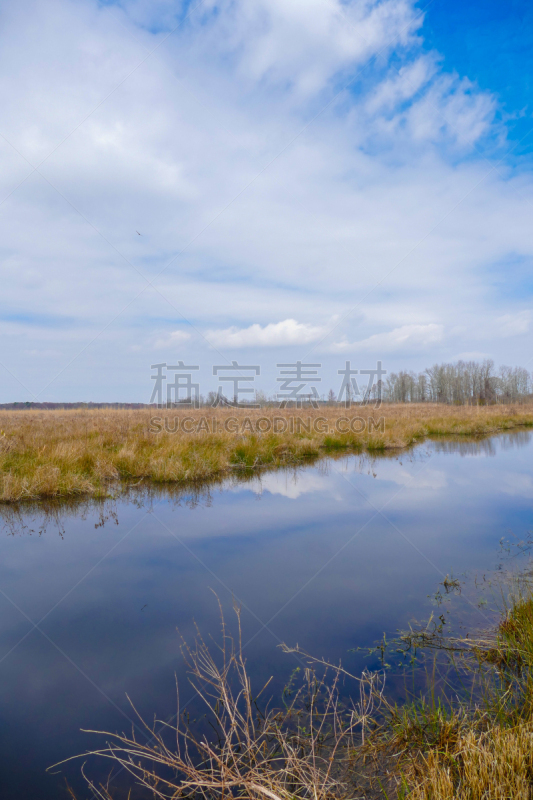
{"left": 205, "top": 319, "right": 328, "bottom": 348}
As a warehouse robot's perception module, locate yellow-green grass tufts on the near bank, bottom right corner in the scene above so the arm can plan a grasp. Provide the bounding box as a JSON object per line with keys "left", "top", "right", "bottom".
{"left": 380, "top": 575, "right": 533, "bottom": 800}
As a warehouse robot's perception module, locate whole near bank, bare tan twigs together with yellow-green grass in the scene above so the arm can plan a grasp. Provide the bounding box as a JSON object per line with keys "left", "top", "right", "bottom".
{"left": 61, "top": 580, "right": 533, "bottom": 800}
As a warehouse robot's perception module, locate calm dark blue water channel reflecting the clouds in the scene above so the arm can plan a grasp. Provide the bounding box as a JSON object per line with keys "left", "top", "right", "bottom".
{"left": 0, "top": 432, "right": 533, "bottom": 800}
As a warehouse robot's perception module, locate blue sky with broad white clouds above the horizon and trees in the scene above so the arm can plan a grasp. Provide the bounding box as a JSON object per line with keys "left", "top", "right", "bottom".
{"left": 0, "top": 0, "right": 533, "bottom": 402}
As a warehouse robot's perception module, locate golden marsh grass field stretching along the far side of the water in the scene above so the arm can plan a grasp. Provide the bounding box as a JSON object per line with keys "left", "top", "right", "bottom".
{"left": 0, "top": 403, "right": 533, "bottom": 503}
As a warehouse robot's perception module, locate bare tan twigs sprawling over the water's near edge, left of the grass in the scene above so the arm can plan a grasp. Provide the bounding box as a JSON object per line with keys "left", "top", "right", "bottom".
{"left": 54, "top": 609, "right": 379, "bottom": 800}
